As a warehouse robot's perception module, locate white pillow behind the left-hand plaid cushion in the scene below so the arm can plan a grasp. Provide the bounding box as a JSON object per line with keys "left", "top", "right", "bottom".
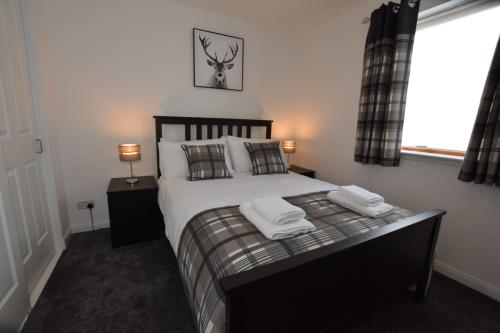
{"left": 158, "top": 138, "right": 234, "bottom": 178}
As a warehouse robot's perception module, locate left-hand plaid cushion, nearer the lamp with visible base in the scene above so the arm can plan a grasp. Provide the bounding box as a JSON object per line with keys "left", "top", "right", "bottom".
{"left": 181, "top": 144, "right": 232, "bottom": 180}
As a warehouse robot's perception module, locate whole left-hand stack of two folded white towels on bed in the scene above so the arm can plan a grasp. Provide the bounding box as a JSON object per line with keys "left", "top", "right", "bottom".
{"left": 240, "top": 196, "right": 316, "bottom": 240}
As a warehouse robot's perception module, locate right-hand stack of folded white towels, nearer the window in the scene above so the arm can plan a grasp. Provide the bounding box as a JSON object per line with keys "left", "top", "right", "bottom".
{"left": 327, "top": 185, "right": 394, "bottom": 217}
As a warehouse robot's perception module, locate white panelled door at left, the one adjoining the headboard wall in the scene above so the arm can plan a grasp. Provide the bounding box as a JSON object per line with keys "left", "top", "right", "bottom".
{"left": 0, "top": 0, "right": 55, "bottom": 326}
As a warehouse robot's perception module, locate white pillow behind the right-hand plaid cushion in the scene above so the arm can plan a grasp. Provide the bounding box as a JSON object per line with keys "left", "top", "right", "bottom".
{"left": 226, "top": 135, "right": 288, "bottom": 172}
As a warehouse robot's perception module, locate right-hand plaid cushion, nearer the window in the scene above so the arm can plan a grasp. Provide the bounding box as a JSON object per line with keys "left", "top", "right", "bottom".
{"left": 244, "top": 141, "right": 288, "bottom": 175}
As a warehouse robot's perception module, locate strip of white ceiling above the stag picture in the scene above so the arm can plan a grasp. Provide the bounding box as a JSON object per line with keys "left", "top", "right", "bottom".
{"left": 173, "top": 0, "right": 358, "bottom": 32}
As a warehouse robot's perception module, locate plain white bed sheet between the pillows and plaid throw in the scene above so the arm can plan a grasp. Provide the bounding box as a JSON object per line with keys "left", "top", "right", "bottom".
{"left": 158, "top": 172, "right": 337, "bottom": 255}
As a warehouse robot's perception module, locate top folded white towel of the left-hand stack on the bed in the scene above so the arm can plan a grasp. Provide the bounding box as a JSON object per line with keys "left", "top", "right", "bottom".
{"left": 250, "top": 195, "right": 306, "bottom": 225}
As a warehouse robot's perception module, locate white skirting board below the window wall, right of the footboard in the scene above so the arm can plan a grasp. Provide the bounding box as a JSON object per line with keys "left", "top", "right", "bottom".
{"left": 434, "top": 259, "right": 500, "bottom": 302}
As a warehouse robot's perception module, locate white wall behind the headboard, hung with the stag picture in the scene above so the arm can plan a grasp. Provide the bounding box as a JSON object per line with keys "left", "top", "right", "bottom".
{"left": 37, "top": 0, "right": 298, "bottom": 231}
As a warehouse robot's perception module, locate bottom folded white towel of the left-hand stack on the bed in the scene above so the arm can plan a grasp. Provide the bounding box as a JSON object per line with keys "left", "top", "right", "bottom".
{"left": 240, "top": 202, "right": 316, "bottom": 240}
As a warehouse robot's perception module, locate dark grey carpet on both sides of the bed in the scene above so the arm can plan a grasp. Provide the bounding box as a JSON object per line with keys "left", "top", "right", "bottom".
{"left": 23, "top": 230, "right": 500, "bottom": 333}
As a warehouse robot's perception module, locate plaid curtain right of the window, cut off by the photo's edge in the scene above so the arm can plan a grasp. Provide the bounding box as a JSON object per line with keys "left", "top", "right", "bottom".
{"left": 458, "top": 37, "right": 500, "bottom": 186}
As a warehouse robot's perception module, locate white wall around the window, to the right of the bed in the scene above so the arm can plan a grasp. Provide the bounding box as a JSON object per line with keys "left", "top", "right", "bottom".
{"left": 294, "top": 0, "right": 500, "bottom": 296}
